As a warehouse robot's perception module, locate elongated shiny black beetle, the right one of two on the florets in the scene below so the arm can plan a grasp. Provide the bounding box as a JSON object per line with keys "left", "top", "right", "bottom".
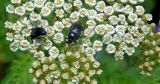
{"left": 67, "top": 22, "right": 83, "bottom": 44}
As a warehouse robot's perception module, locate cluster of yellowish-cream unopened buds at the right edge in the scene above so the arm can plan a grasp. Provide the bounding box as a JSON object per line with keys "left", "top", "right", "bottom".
{"left": 139, "top": 24, "right": 160, "bottom": 76}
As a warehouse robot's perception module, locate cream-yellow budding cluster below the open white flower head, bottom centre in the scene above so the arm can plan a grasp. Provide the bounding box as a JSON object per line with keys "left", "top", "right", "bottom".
{"left": 29, "top": 48, "right": 102, "bottom": 84}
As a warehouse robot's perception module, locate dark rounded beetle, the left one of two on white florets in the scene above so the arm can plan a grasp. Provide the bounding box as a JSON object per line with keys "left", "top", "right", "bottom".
{"left": 30, "top": 27, "right": 47, "bottom": 39}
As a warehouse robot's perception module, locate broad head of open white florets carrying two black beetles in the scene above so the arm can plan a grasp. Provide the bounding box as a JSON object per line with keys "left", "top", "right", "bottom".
{"left": 5, "top": 0, "right": 152, "bottom": 60}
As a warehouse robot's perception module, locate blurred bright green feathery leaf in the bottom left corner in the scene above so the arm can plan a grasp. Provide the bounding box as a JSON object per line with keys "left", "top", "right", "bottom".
{"left": 0, "top": 53, "right": 33, "bottom": 84}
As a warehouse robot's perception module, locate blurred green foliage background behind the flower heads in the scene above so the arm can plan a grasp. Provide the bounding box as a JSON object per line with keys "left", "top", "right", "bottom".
{"left": 0, "top": 0, "right": 160, "bottom": 84}
